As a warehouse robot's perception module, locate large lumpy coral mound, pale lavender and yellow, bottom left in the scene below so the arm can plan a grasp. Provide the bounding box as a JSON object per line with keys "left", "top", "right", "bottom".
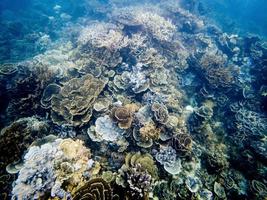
{"left": 12, "top": 139, "right": 91, "bottom": 200}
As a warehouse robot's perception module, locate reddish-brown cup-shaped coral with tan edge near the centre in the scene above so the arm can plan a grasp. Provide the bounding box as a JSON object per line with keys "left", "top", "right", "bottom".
{"left": 110, "top": 104, "right": 138, "bottom": 129}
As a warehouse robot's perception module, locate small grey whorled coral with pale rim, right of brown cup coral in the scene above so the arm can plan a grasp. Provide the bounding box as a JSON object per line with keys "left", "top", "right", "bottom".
{"left": 151, "top": 103, "right": 169, "bottom": 124}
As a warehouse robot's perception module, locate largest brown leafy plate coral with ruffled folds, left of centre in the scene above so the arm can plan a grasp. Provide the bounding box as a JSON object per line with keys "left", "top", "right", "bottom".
{"left": 51, "top": 74, "right": 107, "bottom": 126}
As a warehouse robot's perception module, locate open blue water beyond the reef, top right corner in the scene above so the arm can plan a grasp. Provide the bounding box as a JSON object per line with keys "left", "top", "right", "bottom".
{"left": 200, "top": 0, "right": 267, "bottom": 38}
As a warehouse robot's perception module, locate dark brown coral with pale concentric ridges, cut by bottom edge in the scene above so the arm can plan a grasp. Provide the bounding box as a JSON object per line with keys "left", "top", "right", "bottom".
{"left": 73, "top": 178, "right": 119, "bottom": 200}
